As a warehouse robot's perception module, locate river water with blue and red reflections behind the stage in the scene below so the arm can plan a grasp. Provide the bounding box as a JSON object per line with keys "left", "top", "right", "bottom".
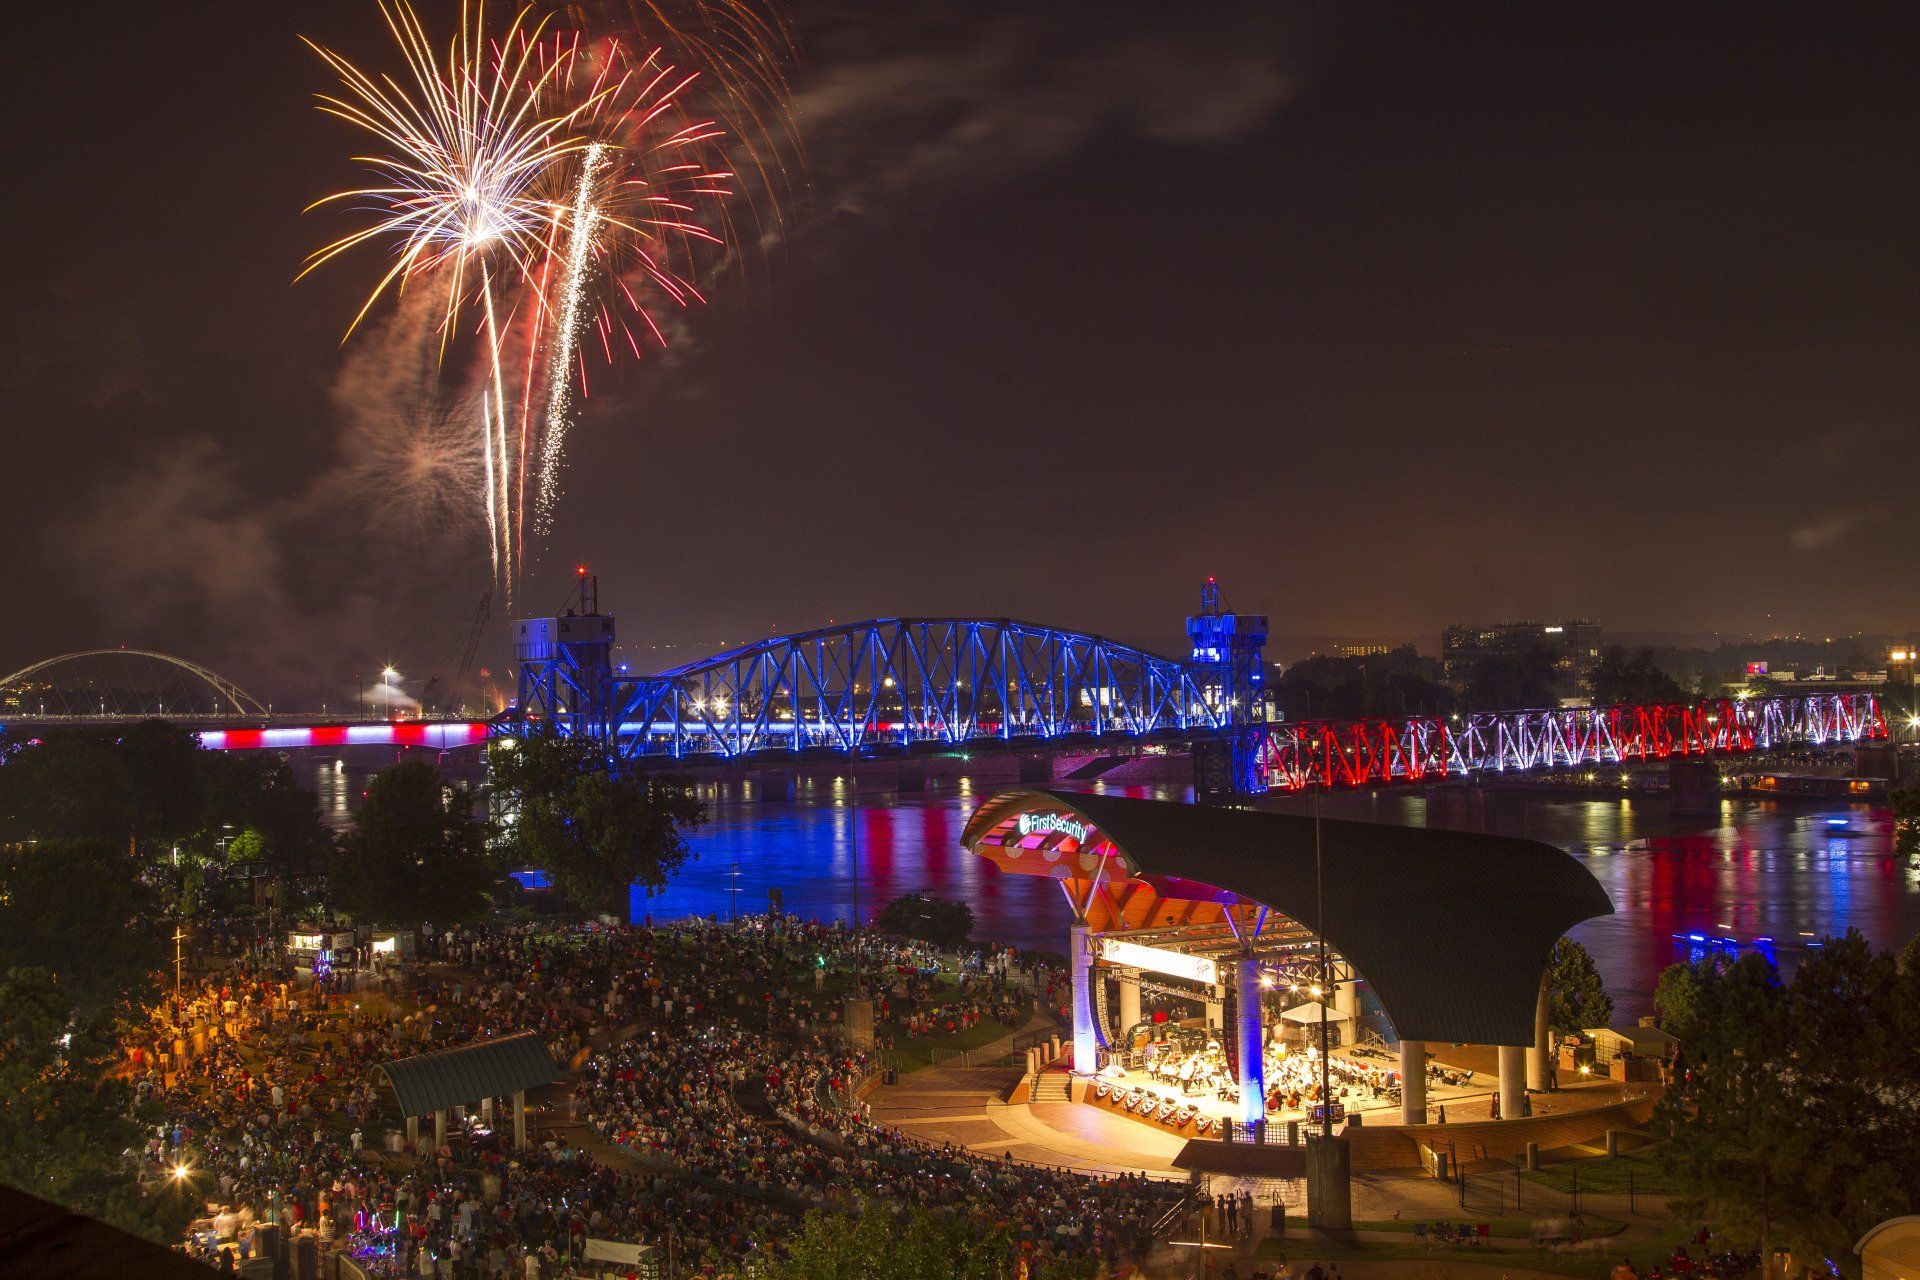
{"left": 634, "top": 785, "right": 1920, "bottom": 1019}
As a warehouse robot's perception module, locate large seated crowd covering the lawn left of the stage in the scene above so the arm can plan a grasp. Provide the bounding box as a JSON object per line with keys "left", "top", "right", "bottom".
{"left": 127, "top": 919, "right": 1167, "bottom": 1278}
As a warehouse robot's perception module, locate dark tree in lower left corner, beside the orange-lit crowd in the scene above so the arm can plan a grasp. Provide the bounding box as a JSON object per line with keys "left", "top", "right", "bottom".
{"left": 0, "top": 967, "right": 192, "bottom": 1244}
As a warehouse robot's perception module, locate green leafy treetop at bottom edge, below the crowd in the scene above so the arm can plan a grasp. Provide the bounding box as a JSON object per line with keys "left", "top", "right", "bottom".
{"left": 764, "top": 1207, "right": 1096, "bottom": 1280}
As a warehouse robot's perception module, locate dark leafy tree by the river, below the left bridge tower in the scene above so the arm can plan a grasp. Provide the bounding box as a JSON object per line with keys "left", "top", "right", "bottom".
{"left": 490, "top": 733, "right": 707, "bottom": 917}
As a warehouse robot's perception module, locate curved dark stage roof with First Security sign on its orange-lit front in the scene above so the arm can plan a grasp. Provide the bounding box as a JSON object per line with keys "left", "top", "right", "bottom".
{"left": 962, "top": 787, "right": 1613, "bottom": 1044}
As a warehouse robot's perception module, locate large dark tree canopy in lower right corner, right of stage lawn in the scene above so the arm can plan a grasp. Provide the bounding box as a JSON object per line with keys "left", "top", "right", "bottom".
{"left": 1655, "top": 931, "right": 1920, "bottom": 1276}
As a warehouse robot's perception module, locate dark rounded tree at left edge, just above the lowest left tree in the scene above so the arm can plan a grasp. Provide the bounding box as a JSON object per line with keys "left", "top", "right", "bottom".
{"left": 0, "top": 841, "right": 167, "bottom": 1009}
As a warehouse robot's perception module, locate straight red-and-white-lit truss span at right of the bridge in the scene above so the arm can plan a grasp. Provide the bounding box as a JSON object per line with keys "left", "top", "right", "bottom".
{"left": 1258, "top": 693, "right": 1887, "bottom": 791}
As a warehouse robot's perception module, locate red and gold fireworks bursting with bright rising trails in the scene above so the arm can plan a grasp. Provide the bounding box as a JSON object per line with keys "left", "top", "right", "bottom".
{"left": 301, "top": 0, "right": 733, "bottom": 597}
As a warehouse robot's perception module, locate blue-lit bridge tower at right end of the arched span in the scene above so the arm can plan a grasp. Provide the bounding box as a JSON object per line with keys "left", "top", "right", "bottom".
{"left": 1187, "top": 576, "right": 1267, "bottom": 800}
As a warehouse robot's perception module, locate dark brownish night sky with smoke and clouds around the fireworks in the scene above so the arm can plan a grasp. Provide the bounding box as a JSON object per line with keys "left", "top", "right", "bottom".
{"left": 0, "top": 0, "right": 1920, "bottom": 704}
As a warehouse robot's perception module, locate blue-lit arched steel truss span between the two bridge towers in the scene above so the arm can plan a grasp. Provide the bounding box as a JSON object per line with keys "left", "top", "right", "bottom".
{"left": 576, "top": 618, "right": 1236, "bottom": 760}
